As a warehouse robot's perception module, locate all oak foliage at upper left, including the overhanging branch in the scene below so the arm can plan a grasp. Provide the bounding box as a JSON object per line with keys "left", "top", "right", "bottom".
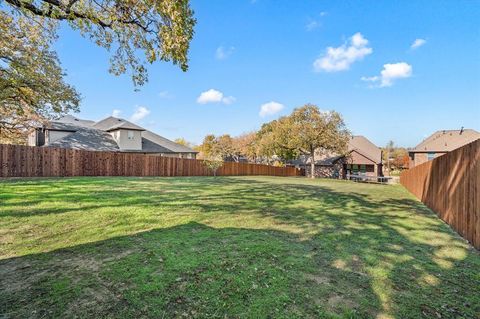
{"left": 0, "top": 0, "right": 196, "bottom": 142}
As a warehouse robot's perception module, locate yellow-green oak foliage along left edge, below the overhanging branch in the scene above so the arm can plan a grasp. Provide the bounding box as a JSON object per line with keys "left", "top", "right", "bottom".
{"left": 0, "top": 11, "right": 80, "bottom": 143}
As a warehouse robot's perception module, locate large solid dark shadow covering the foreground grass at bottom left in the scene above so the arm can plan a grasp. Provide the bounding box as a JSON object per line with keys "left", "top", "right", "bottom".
{"left": 0, "top": 223, "right": 378, "bottom": 318}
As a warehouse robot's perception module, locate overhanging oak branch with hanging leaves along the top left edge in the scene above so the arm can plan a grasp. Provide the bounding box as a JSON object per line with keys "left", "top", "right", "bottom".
{"left": 5, "top": 0, "right": 196, "bottom": 85}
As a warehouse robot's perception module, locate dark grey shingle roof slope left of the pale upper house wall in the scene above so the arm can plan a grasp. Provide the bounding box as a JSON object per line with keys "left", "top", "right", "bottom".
{"left": 48, "top": 127, "right": 119, "bottom": 151}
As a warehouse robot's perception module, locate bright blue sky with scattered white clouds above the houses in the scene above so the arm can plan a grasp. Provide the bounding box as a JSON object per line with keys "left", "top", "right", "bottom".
{"left": 56, "top": 0, "right": 480, "bottom": 147}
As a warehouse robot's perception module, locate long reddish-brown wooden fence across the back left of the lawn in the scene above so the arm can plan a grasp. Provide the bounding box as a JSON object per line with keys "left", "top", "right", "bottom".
{"left": 0, "top": 144, "right": 300, "bottom": 177}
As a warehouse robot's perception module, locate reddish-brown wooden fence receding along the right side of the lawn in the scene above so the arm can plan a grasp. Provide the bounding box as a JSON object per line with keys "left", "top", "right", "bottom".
{"left": 400, "top": 139, "right": 480, "bottom": 249}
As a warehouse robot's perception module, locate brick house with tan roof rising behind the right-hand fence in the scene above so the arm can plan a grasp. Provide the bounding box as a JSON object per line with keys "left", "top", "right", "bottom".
{"left": 408, "top": 128, "right": 480, "bottom": 168}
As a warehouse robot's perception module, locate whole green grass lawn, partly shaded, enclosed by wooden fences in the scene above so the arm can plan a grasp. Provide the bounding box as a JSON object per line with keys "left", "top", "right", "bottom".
{"left": 0, "top": 177, "right": 480, "bottom": 318}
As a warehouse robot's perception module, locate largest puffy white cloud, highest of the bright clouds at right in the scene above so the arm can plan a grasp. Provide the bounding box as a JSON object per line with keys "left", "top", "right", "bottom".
{"left": 313, "top": 32, "right": 373, "bottom": 72}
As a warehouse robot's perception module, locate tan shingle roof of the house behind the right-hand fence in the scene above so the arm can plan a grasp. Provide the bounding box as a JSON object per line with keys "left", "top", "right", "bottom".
{"left": 409, "top": 129, "right": 480, "bottom": 153}
